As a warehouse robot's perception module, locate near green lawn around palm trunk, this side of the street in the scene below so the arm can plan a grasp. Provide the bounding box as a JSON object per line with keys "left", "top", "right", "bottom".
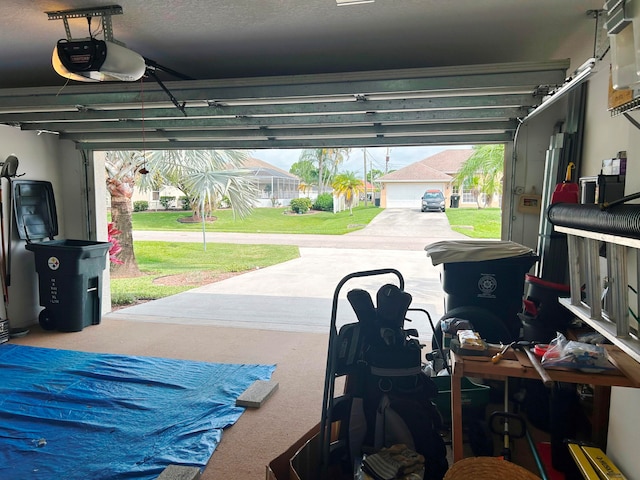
{"left": 111, "top": 241, "right": 300, "bottom": 305}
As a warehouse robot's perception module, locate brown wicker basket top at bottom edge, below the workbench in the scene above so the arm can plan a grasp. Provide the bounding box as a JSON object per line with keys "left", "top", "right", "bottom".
{"left": 443, "top": 457, "right": 541, "bottom": 480}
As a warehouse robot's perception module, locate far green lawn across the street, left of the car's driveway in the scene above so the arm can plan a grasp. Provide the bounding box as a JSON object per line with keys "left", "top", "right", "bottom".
{"left": 133, "top": 206, "right": 382, "bottom": 235}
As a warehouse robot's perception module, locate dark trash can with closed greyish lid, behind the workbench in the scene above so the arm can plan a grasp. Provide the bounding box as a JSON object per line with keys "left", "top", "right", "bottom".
{"left": 425, "top": 240, "right": 539, "bottom": 338}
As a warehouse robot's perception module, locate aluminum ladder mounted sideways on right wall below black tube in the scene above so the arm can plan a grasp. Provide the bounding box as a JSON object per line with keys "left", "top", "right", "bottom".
{"left": 555, "top": 225, "right": 640, "bottom": 363}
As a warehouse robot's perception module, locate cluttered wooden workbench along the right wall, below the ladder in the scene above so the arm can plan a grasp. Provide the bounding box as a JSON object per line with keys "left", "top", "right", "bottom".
{"left": 451, "top": 346, "right": 640, "bottom": 462}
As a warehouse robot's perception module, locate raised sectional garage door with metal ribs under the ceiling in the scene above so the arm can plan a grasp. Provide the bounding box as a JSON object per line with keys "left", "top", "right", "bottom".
{"left": 0, "top": 60, "right": 569, "bottom": 150}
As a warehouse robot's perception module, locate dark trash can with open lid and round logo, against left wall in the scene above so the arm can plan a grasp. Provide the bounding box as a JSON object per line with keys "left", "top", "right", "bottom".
{"left": 12, "top": 180, "right": 111, "bottom": 332}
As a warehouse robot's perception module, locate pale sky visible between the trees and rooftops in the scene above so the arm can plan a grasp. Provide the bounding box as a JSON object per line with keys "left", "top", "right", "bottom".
{"left": 251, "top": 145, "right": 471, "bottom": 175}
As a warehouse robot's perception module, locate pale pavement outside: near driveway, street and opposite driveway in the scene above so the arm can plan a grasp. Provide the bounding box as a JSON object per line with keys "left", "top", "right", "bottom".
{"left": 105, "top": 209, "right": 467, "bottom": 339}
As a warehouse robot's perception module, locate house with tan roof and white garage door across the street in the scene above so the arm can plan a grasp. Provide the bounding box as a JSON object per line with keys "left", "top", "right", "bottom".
{"left": 378, "top": 149, "right": 475, "bottom": 208}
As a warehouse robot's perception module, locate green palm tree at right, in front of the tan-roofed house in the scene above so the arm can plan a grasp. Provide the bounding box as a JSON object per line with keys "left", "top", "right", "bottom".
{"left": 454, "top": 145, "right": 504, "bottom": 208}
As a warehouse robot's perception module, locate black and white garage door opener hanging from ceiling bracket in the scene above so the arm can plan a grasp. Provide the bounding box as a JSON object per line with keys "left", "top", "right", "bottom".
{"left": 46, "top": 5, "right": 147, "bottom": 82}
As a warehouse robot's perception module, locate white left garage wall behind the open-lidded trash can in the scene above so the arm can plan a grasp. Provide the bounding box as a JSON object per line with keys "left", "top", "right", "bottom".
{"left": 0, "top": 125, "right": 109, "bottom": 330}
